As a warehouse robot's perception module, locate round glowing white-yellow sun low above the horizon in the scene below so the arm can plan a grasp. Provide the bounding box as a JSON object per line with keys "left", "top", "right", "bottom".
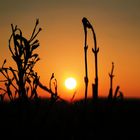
{"left": 65, "top": 77, "right": 77, "bottom": 90}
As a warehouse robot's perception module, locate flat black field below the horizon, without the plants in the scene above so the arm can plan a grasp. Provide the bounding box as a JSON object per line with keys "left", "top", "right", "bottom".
{"left": 0, "top": 99, "right": 140, "bottom": 140}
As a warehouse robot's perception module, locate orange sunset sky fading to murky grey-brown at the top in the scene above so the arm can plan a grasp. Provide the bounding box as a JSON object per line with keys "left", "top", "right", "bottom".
{"left": 0, "top": 0, "right": 140, "bottom": 99}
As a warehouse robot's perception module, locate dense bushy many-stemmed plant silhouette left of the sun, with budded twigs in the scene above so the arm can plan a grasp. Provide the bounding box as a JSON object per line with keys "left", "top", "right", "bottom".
{"left": 0, "top": 19, "right": 41, "bottom": 100}
